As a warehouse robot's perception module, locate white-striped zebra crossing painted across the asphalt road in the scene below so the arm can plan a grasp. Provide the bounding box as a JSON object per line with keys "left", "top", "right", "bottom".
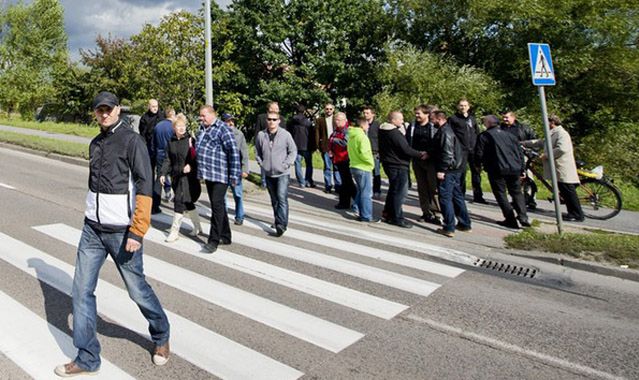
{"left": 0, "top": 205, "right": 473, "bottom": 379}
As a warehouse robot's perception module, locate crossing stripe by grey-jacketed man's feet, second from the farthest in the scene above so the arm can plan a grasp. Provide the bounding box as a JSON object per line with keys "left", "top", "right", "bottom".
{"left": 240, "top": 214, "right": 464, "bottom": 278}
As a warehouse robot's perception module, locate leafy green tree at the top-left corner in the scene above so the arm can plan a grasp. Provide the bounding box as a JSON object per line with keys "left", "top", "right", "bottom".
{"left": 0, "top": 0, "right": 68, "bottom": 118}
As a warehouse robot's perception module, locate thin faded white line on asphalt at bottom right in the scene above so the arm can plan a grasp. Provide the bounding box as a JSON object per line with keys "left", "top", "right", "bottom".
{"left": 406, "top": 314, "right": 624, "bottom": 380}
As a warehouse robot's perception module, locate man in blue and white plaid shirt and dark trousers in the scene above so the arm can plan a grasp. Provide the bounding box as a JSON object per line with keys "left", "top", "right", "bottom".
{"left": 196, "top": 106, "right": 242, "bottom": 253}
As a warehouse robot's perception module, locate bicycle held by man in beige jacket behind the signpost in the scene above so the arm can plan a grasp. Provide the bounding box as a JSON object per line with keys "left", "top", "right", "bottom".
{"left": 522, "top": 148, "right": 622, "bottom": 220}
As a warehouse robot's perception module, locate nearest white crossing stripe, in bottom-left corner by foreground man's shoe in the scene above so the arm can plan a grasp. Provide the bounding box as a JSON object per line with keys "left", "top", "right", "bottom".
{"left": 0, "top": 291, "right": 134, "bottom": 379}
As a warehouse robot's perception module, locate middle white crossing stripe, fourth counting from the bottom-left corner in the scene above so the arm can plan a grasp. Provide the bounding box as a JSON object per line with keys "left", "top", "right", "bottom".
{"left": 151, "top": 214, "right": 408, "bottom": 319}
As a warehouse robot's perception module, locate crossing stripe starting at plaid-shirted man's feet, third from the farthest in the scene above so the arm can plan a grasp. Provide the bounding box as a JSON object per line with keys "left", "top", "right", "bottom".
{"left": 184, "top": 214, "right": 441, "bottom": 296}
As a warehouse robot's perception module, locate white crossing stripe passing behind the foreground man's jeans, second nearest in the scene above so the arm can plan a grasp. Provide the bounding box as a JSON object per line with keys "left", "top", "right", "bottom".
{"left": 0, "top": 233, "right": 304, "bottom": 380}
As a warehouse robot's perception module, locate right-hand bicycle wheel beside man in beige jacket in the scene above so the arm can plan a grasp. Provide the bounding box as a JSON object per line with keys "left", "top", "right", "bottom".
{"left": 576, "top": 178, "right": 621, "bottom": 220}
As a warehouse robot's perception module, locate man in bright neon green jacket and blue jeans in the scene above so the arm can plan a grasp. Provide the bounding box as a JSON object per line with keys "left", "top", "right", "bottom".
{"left": 347, "top": 117, "right": 375, "bottom": 222}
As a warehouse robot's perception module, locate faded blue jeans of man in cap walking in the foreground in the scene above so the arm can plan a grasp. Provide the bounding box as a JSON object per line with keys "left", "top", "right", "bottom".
{"left": 72, "top": 223, "right": 170, "bottom": 371}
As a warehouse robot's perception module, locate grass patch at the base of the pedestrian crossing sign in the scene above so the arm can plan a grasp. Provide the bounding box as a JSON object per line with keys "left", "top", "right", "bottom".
{"left": 504, "top": 228, "right": 639, "bottom": 268}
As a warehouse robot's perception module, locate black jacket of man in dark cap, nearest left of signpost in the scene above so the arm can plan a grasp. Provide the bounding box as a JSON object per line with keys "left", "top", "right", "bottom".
{"left": 475, "top": 127, "right": 524, "bottom": 175}
